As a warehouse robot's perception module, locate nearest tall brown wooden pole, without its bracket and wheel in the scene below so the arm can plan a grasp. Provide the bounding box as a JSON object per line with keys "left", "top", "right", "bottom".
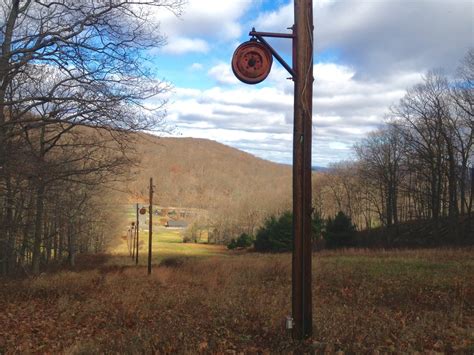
{"left": 292, "top": 0, "right": 313, "bottom": 339}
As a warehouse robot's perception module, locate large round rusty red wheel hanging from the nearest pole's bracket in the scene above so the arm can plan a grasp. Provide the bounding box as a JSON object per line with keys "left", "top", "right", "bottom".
{"left": 232, "top": 40, "right": 273, "bottom": 84}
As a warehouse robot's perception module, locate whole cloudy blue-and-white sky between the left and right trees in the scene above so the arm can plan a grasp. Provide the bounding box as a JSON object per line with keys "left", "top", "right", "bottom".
{"left": 148, "top": 0, "right": 474, "bottom": 166}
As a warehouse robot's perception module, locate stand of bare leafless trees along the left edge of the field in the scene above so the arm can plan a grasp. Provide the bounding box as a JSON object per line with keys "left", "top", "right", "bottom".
{"left": 0, "top": 0, "right": 181, "bottom": 275}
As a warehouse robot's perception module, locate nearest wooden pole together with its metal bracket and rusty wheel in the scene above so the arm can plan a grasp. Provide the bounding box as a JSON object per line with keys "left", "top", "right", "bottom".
{"left": 232, "top": 0, "right": 313, "bottom": 339}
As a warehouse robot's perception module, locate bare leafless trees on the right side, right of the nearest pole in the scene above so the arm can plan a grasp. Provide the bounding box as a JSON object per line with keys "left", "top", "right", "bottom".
{"left": 314, "top": 49, "right": 474, "bottom": 244}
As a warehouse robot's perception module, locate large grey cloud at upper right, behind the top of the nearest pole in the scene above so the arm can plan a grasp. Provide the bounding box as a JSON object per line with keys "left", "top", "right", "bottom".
{"left": 255, "top": 0, "right": 474, "bottom": 78}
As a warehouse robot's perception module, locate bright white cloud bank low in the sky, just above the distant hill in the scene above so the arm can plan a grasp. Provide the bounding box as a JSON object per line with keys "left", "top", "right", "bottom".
{"left": 153, "top": 63, "right": 426, "bottom": 165}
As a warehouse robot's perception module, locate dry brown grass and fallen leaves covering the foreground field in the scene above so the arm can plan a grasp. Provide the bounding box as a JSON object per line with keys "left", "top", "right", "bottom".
{"left": 0, "top": 249, "right": 474, "bottom": 353}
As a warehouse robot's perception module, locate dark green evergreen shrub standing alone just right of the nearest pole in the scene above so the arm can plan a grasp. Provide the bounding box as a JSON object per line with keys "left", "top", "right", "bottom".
{"left": 323, "top": 211, "right": 356, "bottom": 248}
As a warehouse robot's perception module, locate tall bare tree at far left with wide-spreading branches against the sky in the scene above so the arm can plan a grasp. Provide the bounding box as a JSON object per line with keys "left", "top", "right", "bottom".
{"left": 0, "top": 0, "right": 182, "bottom": 273}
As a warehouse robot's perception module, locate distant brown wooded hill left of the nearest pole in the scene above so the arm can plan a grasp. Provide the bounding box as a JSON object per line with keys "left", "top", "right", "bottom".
{"left": 128, "top": 134, "right": 292, "bottom": 218}
